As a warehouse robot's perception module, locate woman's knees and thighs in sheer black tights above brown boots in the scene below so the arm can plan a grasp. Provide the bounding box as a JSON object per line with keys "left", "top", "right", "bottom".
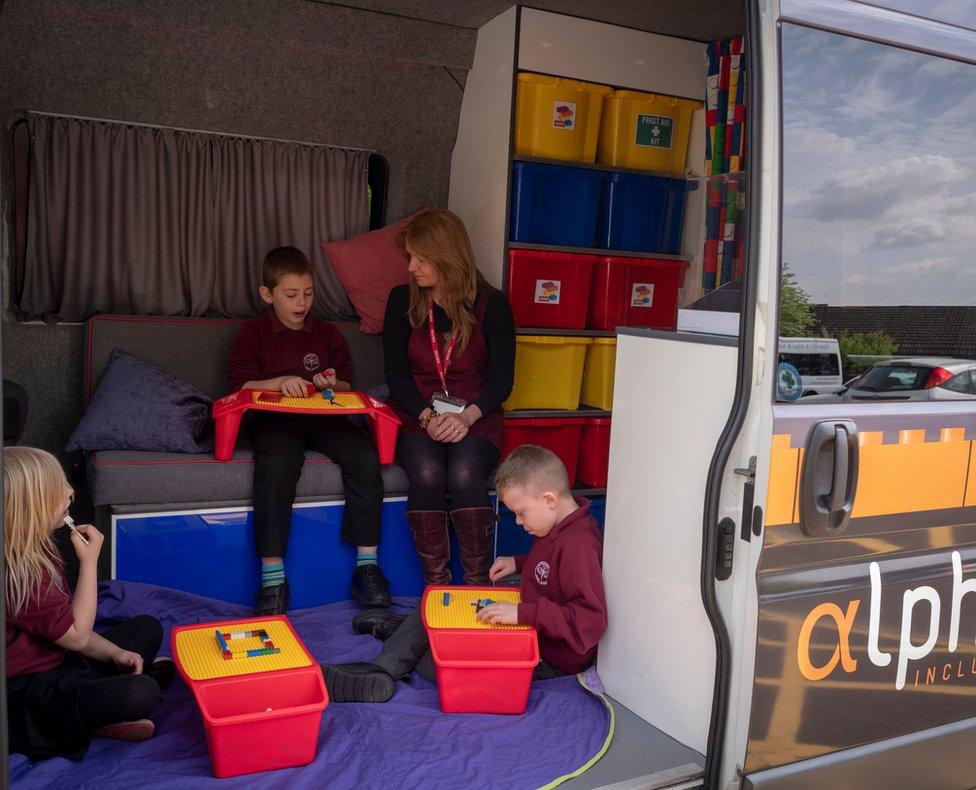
{"left": 397, "top": 436, "right": 498, "bottom": 510}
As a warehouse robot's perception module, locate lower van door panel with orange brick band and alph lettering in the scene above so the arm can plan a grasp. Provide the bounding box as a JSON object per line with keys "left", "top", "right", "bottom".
{"left": 746, "top": 404, "right": 976, "bottom": 773}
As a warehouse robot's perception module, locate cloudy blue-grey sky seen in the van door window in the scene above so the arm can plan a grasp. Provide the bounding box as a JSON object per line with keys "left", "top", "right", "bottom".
{"left": 782, "top": 21, "right": 976, "bottom": 305}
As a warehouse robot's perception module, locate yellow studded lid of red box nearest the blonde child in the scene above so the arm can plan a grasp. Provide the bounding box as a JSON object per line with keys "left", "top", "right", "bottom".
{"left": 176, "top": 620, "right": 312, "bottom": 680}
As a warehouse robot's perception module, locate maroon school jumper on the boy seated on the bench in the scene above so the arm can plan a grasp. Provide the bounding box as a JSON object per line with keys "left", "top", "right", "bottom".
{"left": 227, "top": 310, "right": 352, "bottom": 392}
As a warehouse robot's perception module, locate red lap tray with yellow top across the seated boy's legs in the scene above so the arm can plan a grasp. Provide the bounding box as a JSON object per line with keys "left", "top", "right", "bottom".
{"left": 213, "top": 387, "right": 400, "bottom": 464}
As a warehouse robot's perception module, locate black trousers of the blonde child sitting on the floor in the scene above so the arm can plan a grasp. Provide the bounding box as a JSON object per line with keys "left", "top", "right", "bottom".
{"left": 7, "top": 615, "right": 163, "bottom": 760}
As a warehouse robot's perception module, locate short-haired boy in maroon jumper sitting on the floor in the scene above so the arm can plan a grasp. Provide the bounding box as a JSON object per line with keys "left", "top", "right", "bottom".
{"left": 322, "top": 444, "right": 607, "bottom": 702}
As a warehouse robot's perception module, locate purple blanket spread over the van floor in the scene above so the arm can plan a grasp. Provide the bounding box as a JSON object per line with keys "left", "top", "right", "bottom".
{"left": 9, "top": 582, "right": 610, "bottom": 790}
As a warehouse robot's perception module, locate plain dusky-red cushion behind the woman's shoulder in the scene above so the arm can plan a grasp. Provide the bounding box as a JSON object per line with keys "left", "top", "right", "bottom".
{"left": 322, "top": 209, "right": 427, "bottom": 335}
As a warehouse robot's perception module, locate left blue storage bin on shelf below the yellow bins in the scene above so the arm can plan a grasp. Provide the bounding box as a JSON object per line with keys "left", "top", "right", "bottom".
{"left": 511, "top": 162, "right": 610, "bottom": 247}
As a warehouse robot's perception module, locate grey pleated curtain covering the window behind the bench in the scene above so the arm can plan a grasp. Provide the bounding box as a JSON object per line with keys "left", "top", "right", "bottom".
{"left": 19, "top": 115, "right": 369, "bottom": 321}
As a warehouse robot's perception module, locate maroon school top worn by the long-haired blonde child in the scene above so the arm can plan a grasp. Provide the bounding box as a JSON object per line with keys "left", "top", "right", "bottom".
{"left": 6, "top": 573, "right": 75, "bottom": 677}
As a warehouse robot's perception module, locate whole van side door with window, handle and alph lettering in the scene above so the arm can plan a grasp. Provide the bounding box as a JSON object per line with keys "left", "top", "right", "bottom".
{"left": 740, "top": 0, "right": 976, "bottom": 788}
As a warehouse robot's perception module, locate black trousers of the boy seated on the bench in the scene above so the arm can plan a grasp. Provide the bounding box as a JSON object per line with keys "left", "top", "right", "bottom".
{"left": 251, "top": 412, "right": 383, "bottom": 557}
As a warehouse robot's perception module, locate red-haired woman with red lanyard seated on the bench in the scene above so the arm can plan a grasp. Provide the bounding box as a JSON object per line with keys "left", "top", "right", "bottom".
{"left": 383, "top": 209, "right": 515, "bottom": 584}
